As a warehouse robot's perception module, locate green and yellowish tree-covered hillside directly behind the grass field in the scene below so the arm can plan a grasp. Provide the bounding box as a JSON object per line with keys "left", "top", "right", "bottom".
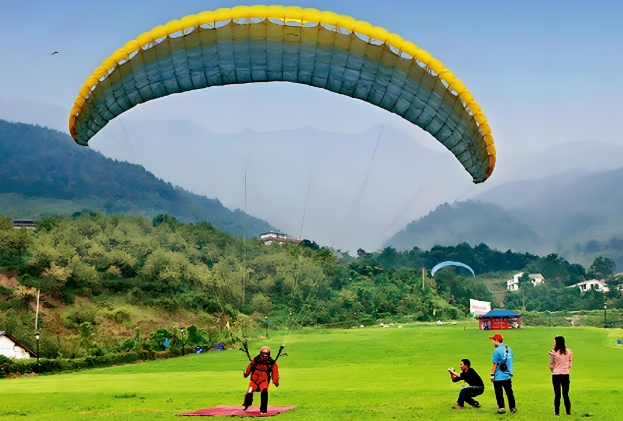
{"left": 0, "top": 212, "right": 623, "bottom": 356}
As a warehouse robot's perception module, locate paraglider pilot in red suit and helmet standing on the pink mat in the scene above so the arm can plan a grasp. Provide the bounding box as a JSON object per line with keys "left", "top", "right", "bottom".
{"left": 242, "top": 346, "right": 279, "bottom": 414}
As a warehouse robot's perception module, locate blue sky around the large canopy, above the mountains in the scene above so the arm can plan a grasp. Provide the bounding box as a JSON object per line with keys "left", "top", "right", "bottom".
{"left": 0, "top": 0, "right": 623, "bottom": 249}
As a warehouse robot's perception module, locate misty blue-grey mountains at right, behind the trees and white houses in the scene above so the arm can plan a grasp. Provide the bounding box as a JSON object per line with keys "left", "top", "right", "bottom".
{"left": 387, "top": 168, "right": 623, "bottom": 269}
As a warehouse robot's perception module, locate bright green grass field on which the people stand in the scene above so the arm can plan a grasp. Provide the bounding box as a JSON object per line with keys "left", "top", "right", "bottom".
{"left": 0, "top": 322, "right": 623, "bottom": 421}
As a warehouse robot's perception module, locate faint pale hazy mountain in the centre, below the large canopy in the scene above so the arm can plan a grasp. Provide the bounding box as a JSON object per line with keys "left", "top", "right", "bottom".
{"left": 92, "top": 121, "right": 472, "bottom": 251}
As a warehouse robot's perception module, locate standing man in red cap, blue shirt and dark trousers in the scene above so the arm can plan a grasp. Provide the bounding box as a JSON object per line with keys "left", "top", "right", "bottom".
{"left": 489, "top": 333, "right": 517, "bottom": 414}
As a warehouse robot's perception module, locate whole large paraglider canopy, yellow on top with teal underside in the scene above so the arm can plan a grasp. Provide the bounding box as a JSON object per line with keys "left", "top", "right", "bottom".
{"left": 69, "top": 6, "right": 496, "bottom": 183}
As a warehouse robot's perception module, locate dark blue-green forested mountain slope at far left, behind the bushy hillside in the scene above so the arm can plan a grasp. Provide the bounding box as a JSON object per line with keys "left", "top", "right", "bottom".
{"left": 0, "top": 120, "right": 273, "bottom": 235}
